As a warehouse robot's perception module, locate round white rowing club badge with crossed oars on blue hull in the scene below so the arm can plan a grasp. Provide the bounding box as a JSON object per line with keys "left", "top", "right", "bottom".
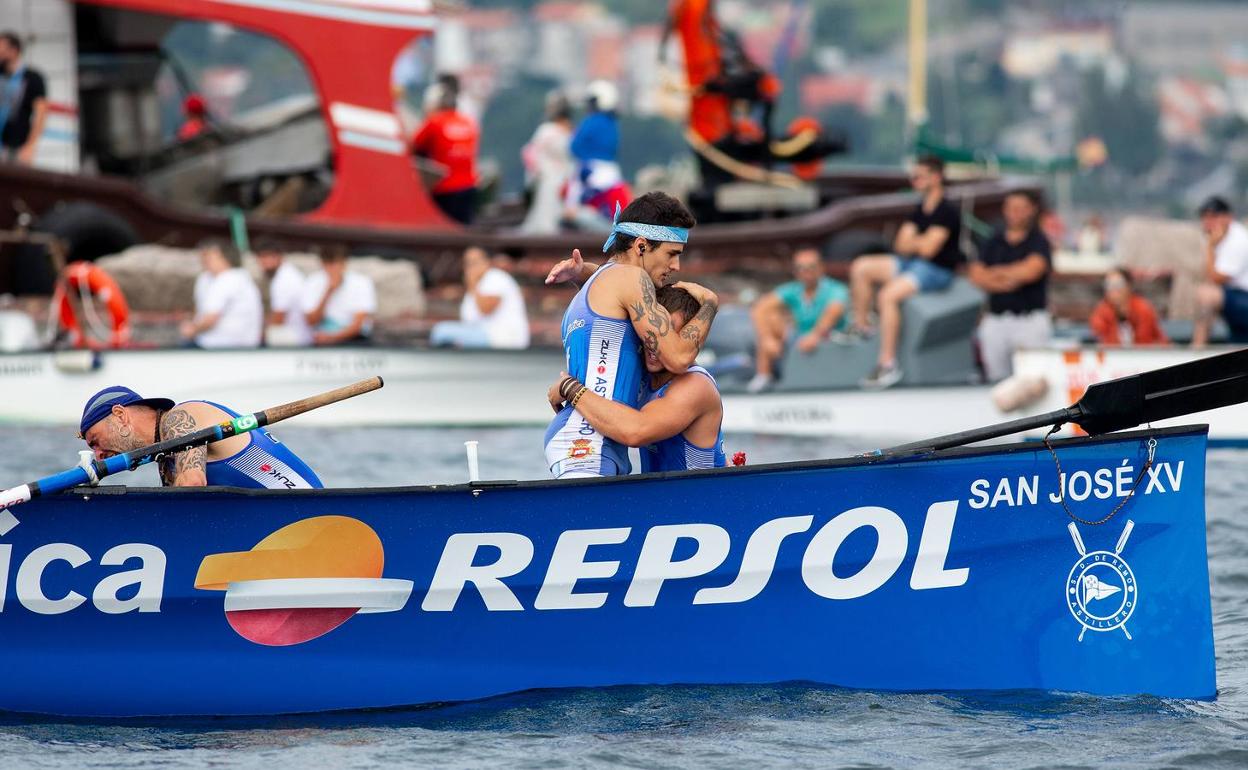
{"left": 1066, "top": 519, "right": 1139, "bottom": 641}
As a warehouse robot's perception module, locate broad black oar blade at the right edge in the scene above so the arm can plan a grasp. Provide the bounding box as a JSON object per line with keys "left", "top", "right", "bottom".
{"left": 1072, "top": 349, "right": 1248, "bottom": 436}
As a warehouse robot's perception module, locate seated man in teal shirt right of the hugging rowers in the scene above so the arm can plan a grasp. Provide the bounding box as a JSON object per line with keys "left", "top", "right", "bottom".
{"left": 746, "top": 246, "right": 850, "bottom": 393}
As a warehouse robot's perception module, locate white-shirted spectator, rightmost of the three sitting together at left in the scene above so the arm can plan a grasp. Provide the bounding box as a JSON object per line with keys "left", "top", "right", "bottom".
{"left": 301, "top": 245, "right": 377, "bottom": 344}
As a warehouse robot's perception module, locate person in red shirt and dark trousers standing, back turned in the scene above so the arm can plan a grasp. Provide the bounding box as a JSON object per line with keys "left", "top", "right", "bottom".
{"left": 412, "top": 79, "right": 480, "bottom": 225}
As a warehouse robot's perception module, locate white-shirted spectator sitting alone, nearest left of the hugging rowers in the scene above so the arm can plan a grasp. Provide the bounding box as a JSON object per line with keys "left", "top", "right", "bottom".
{"left": 429, "top": 246, "right": 529, "bottom": 349}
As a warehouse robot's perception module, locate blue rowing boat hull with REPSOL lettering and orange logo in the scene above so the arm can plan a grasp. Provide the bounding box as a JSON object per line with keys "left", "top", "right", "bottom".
{"left": 0, "top": 427, "right": 1217, "bottom": 716}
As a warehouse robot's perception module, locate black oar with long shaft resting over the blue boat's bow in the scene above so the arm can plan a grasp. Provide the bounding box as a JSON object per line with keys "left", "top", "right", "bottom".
{"left": 874, "top": 349, "right": 1248, "bottom": 457}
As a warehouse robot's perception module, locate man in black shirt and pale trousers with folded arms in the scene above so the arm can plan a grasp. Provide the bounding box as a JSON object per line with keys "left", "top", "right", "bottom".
{"left": 967, "top": 191, "right": 1053, "bottom": 382}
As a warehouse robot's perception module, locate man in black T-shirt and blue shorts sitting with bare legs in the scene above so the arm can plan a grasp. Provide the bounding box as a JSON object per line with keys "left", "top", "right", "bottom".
{"left": 850, "top": 156, "right": 963, "bottom": 388}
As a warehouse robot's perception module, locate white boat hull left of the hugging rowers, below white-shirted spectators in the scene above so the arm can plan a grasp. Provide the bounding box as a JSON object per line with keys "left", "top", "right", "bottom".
{"left": 0, "top": 348, "right": 564, "bottom": 427}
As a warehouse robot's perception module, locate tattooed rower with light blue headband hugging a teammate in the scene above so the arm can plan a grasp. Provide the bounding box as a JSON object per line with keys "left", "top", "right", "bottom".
{"left": 545, "top": 192, "right": 719, "bottom": 478}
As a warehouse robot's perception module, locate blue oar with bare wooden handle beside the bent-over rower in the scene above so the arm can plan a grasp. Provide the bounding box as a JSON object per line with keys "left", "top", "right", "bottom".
{"left": 0, "top": 377, "right": 384, "bottom": 514}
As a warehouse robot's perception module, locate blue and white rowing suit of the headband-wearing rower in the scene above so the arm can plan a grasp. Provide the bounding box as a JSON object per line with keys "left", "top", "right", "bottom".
{"left": 545, "top": 262, "right": 645, "bottom": 478}
